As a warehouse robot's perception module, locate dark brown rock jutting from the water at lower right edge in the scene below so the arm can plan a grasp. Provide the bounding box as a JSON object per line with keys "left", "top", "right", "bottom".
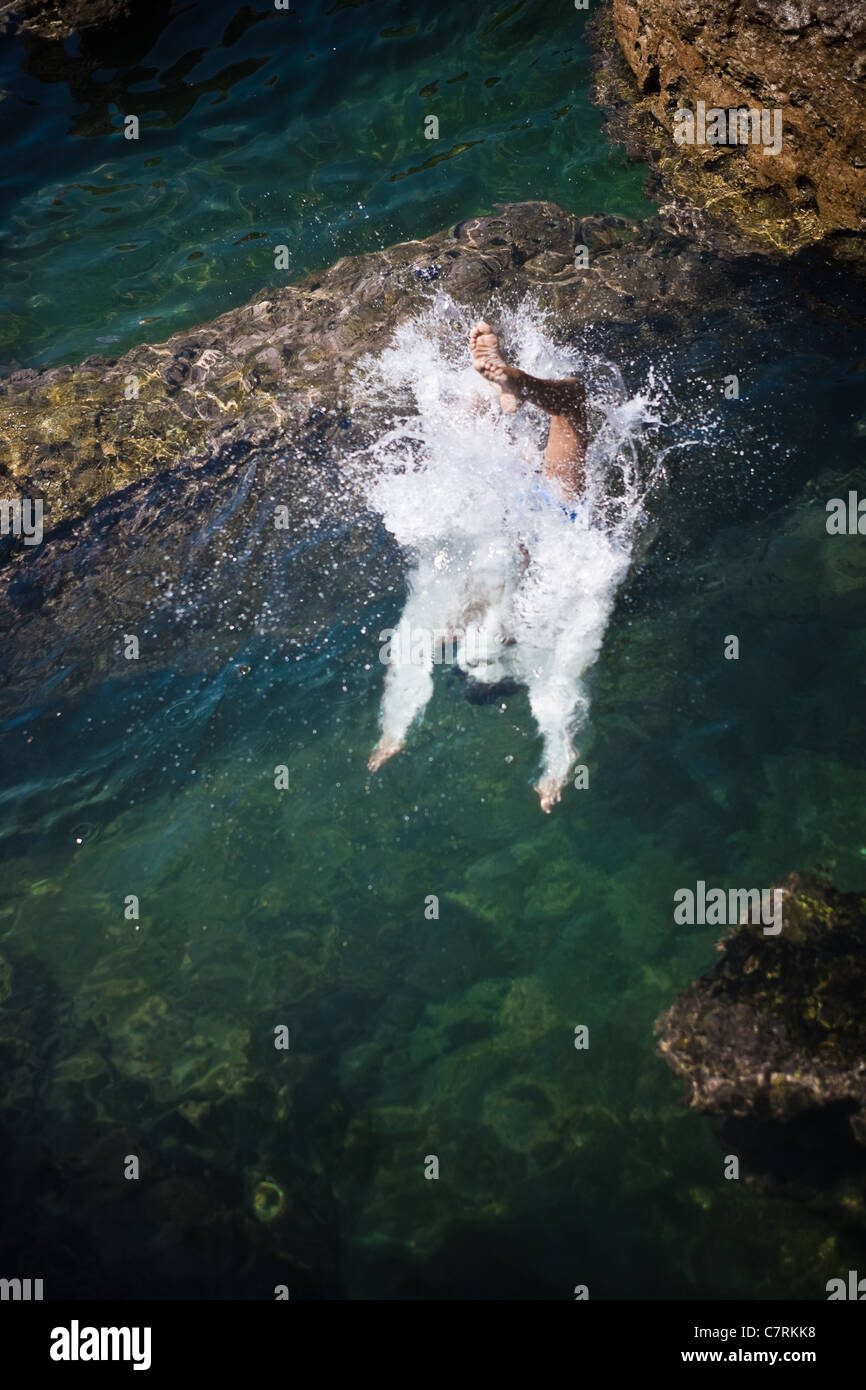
{"left": 656, "top": 874, "right": 866, "bottom": 1161}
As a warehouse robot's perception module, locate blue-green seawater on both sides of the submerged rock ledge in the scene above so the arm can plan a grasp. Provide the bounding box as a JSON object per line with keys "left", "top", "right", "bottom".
{"left": 0, "top": 4, "right": 866, "bottom": 1298}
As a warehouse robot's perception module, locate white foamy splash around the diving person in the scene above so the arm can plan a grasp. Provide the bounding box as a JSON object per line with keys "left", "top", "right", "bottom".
{"left": 353, "top": 295, "right": 656, "bottom": 803}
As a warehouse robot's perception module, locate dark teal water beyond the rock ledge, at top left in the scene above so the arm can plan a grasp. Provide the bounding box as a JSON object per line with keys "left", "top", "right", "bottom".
{"left": 0, "top": 0, "right": 651, "bottom": 366}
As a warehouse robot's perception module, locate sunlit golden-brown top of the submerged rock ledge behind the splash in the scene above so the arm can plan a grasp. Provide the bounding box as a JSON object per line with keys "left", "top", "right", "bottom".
{"left": 0, "top": 203, "right": 722, "bottom": 542}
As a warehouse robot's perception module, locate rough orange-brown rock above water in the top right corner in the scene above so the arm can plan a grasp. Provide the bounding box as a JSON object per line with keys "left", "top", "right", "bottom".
{"left": 596, "top": 0, "right": 866, "bottom": 252}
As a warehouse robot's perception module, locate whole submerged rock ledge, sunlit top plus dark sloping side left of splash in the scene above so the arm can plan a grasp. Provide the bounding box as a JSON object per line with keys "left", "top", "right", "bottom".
{"left": 0, "top": 203, "right": 866, "bottom": 708}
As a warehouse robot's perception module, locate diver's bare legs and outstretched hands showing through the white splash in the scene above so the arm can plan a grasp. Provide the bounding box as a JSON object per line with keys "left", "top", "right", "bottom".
{"left": 367, "top": 320, "right": 587, "bottom": 812}
